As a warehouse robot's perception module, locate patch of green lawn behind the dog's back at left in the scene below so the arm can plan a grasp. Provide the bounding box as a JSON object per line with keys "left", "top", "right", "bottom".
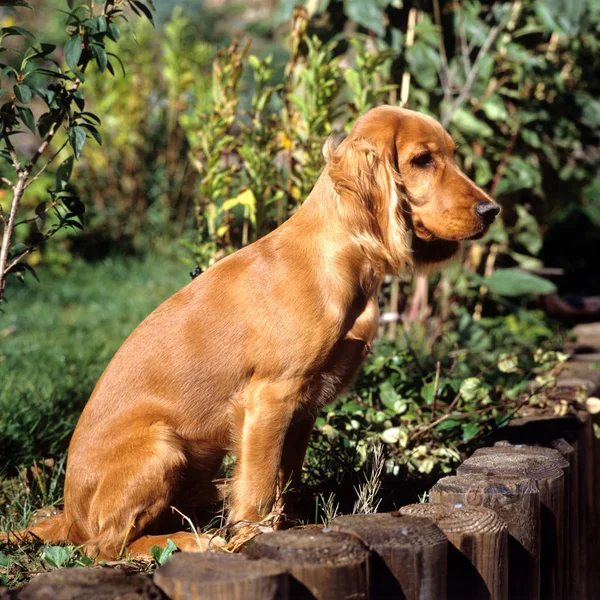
{"left": 0, "top": 256, "right": 190, "bottom": 475}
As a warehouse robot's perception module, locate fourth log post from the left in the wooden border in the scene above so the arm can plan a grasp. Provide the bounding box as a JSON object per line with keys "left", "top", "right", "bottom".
{"left": 331, "top": 513, "right": 448, "bottom": 600}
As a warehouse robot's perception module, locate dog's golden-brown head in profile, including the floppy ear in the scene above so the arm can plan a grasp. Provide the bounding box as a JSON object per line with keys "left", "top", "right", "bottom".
{"left": 325, "top": 106, "right": 500, "bottom": 272}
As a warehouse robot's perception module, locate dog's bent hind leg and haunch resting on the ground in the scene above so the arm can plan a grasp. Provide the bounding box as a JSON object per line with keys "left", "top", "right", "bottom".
{"left": 65, "top": 421, "right": 218, "bottom": 558}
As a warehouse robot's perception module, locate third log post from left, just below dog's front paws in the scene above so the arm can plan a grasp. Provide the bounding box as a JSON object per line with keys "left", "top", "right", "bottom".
{"left": 244, "top": 529, "right": 369, "bottom": 600}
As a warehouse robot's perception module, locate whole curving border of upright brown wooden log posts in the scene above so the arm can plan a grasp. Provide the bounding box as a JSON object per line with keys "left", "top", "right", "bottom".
{"left": 8, "top": 340, "right": 600, "bottom": 600}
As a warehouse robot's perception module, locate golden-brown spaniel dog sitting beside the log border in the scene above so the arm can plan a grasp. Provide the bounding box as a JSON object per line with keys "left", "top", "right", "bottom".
{"left": 3, "top": 106, "right": 499, "bottom": 558}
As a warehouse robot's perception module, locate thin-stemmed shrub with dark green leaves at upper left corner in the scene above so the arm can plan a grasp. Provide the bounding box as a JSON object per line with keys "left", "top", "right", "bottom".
{"left": 0, "top": 0, "right": 152, "bottom": 302}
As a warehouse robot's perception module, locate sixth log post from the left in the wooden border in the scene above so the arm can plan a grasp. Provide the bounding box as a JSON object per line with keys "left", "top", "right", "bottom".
{"left": 429, "top": 474, "right": 540, "bottom": 600}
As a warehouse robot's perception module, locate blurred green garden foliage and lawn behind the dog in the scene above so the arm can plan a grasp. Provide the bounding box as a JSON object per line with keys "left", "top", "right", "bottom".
{"left": 0, "top": 0, "right": 600, "bottom": 580}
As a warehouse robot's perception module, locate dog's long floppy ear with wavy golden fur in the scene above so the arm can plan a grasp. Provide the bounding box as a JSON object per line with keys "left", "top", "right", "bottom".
{"left": 323, "top": 135, "right": 411, "bottom": 273}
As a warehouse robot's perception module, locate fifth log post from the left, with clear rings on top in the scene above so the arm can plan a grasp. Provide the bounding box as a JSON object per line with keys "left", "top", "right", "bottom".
{"left": 399, "top": 503, "right": 508, "bottom": 600}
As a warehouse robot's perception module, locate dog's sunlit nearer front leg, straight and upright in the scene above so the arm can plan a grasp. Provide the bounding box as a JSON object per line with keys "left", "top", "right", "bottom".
{"left": 229, "top": 390, "right": 295, "bottom": 523}
